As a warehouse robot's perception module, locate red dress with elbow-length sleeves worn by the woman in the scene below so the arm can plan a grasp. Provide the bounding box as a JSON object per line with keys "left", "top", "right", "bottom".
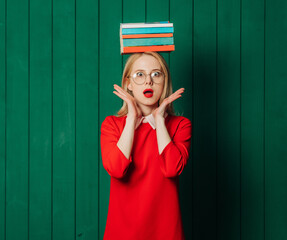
{"left": 101, "top": 115, "right": 192, "bottom": 240}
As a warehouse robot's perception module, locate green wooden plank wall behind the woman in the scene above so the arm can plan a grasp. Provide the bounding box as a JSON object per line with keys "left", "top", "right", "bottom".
{"left": 0, "top": 0, "right": 287, "bottom": 240}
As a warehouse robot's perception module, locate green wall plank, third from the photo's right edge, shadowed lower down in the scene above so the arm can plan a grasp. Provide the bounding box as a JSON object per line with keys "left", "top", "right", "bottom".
{"left": 216, "top": 0, "right": 240, "bottom": 240}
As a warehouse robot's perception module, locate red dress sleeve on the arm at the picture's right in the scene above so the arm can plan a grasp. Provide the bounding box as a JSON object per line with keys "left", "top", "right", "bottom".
{"left": 159, "top": 118, "right": 192, "bottom": 177}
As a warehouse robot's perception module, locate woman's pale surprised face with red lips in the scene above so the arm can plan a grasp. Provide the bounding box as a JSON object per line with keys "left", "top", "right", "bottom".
{"left": 128, "top": 54, "right": 164, "bottom": 107}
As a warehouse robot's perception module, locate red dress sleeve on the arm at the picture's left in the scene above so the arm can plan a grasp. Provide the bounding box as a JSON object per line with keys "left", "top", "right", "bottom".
{"left": 101, "top": 116, "right": 132, "bottom": 178}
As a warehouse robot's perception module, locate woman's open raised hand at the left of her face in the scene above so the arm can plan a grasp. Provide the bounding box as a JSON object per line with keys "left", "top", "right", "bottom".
{"left": 113, "top": 84, "right": 142, "bottom": 121}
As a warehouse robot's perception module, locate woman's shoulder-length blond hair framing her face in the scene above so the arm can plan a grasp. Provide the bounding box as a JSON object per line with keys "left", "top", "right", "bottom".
{"left": 117, "top": 52, "right": 175, "bottom": 117}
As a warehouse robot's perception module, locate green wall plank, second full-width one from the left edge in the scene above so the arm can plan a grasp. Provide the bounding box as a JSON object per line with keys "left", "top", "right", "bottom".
{"left": 29, "top": 1, "right": 52, "bottom": 240}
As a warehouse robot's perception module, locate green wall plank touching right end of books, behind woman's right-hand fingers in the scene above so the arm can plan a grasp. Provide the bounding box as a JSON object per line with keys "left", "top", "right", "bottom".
{"left": 170, "top": 0, "right": 194, "bottom": 239}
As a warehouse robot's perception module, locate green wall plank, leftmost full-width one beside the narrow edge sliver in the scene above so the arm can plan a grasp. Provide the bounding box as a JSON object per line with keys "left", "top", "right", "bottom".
{"left": 6, "top": 0, "right": 29, "bottom": 240}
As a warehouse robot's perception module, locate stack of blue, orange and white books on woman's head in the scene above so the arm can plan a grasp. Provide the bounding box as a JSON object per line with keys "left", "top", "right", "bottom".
{"left": 120, "top": 21, "right": 174, "bottom": 55}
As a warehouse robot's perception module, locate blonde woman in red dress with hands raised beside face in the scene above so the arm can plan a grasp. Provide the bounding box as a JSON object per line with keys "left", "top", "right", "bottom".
{"left": 101, "top": 52, "right": 192, "bottom": 240}
